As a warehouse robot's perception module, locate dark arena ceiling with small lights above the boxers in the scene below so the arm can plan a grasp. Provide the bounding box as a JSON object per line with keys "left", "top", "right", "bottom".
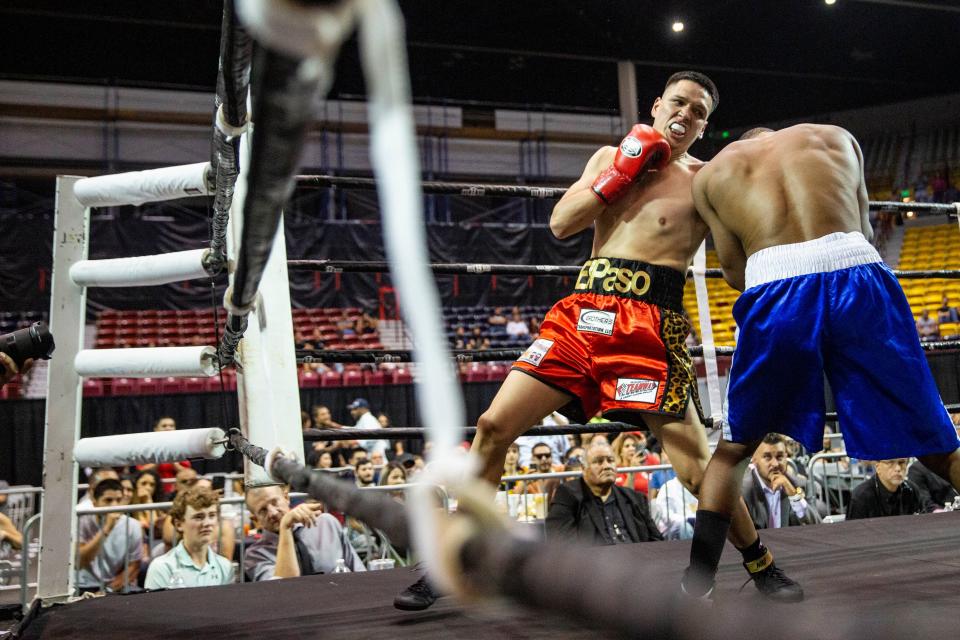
{"left": 0, "top": 0, "right": 960, "bottom": 128}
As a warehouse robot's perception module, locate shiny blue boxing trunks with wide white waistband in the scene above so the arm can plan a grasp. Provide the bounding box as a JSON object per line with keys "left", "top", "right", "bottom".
{"left": 724, "top": 232, "right": 960, "bottom": 460}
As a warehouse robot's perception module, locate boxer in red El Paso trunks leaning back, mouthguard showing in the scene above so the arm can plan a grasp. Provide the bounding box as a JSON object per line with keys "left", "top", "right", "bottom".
{"left": 394, "top": 71, "right": 802, "bottom": 609}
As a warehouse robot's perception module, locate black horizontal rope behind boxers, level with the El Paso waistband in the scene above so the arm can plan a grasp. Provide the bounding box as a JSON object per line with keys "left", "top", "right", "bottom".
{"left": 287, "top": 260, "right": 960, "bottom": 280}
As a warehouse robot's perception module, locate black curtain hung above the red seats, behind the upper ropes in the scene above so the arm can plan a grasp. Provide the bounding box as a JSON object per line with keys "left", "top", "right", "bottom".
{"left": 0, "top": 204, "right": 592, "bottom": 311}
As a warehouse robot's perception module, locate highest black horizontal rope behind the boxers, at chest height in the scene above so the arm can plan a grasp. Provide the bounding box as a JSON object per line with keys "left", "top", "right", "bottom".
{"left": 297, "top": 175, "right": 957, "bottom": 215}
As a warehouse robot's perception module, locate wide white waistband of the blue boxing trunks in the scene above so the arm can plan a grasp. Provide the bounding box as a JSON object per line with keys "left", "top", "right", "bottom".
{"left": 745, "top": 231, "right": 881, "bottom": 289}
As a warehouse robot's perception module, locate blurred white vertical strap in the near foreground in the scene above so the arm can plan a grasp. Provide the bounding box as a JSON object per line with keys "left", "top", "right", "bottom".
{"left": 357, "top": 0, "right": 468, "bottom": 589}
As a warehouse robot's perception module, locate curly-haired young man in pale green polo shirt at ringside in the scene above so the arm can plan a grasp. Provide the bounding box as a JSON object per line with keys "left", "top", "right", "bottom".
{"left": 144, "top": 485, "right": 233, "bottom": 589}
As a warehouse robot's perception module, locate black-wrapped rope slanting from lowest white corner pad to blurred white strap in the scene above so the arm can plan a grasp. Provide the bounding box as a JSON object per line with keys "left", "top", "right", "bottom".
{"left": 230, "top": 429, "right": 410, "bottom": 547}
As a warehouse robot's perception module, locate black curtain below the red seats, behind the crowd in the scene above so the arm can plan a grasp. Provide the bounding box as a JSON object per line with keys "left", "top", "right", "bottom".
{"left": 0, "top": 383, "right": 499, "bottom": 486}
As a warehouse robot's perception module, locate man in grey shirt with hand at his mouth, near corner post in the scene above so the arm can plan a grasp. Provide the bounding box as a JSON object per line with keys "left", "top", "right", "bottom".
{"left": 243, "top": 486, "right": 366, "bottom": 582}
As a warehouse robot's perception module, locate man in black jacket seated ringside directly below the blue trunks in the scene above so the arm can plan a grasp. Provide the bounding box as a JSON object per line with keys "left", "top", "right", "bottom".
{"left": 847, "top": 458, "right": 933, "bottom": 520}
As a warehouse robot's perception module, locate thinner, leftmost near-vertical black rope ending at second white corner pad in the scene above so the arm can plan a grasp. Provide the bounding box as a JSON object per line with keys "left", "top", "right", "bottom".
{"left": 204, "top": 0, "right": 253, "bottom": 275}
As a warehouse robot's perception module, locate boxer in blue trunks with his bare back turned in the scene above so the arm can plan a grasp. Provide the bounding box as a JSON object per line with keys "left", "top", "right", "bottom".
{"left": 682, "top": 124, "right": 960, "bottom": 597}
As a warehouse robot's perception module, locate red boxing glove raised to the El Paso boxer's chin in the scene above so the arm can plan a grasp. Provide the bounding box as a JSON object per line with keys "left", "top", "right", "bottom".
{"left": 592, "top": 124, "right": 670, "bottom": 204}
